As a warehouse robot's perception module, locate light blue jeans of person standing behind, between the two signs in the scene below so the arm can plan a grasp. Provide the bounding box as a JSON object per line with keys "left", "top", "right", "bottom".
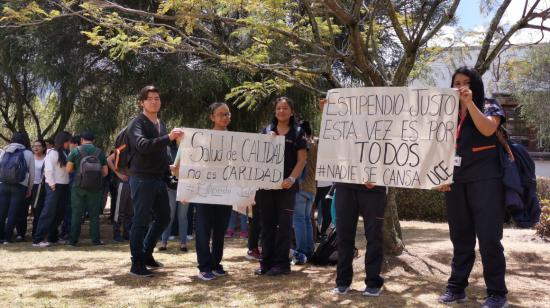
{"left": 292, "top": 190, "right": 315, "bottom": 256}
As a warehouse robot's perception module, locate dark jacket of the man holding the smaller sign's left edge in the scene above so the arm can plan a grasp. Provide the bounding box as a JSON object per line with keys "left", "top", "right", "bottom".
{"left": 127, "top": 114, "right": 170, "bottom": 179}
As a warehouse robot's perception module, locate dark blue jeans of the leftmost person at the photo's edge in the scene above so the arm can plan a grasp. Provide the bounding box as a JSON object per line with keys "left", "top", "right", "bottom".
{"left": 0, "top": 183, "right": 27, "bottom": 242}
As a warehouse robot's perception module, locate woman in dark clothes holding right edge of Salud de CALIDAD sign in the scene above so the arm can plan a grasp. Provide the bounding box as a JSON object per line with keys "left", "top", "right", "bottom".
{"left": 255, "top": 97, "right": 308, "bottom": 276}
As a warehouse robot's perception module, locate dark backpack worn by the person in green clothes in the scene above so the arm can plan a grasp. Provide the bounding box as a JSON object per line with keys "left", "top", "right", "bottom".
{"left": 75, "top": 146, "right": 103, "bottom": 191}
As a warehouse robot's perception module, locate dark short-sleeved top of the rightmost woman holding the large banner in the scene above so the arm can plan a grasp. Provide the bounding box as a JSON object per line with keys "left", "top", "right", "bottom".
{"left": 453, "top": 99, "right": 506, "bottom": 183}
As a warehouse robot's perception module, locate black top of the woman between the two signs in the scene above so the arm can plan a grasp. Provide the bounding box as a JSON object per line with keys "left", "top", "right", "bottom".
{"left": 262, "top": 124, "right": 309, "bottom": 187}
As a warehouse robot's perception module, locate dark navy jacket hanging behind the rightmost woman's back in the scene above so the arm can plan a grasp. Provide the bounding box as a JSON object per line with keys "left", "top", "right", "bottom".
{"left": 500, "top": 142, "right": 541, "bottom": 228}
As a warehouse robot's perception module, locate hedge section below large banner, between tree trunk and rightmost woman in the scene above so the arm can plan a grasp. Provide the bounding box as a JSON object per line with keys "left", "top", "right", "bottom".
{"left": 395, "top": 188, "right": 447, "bottom": 222}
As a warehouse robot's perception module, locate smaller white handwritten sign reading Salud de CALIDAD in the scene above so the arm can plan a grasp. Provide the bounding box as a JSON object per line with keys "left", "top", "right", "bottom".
{"left": 177, "top": 128, "right": 285, "bottom": 207}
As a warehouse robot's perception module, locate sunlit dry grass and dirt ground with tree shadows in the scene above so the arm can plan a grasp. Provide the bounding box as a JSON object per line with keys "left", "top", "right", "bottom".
{"left": 0, "top": 221, "right": 550, "bottom": 307}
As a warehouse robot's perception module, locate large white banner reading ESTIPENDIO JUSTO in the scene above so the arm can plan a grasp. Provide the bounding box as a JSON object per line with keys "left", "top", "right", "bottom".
{"left": 316, "top": 87, "right": 459, "bottom": 189}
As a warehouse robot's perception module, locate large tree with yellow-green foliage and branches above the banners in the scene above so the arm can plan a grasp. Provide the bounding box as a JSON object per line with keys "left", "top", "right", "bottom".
{"left": 0, "top": 0, "right": 550, "bottom": 254}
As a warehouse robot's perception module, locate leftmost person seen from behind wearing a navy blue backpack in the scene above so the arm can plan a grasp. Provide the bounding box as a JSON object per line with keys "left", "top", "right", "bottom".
{"left": 0, "top": 132, "right": 34, "bottom": 244}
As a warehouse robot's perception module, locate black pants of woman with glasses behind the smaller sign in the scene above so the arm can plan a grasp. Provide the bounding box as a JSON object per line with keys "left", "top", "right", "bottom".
{"left": 195, "top": 204, "right": 233, "bottom": 272}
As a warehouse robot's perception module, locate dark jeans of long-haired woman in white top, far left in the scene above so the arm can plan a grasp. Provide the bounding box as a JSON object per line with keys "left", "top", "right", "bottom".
{"left": 33, "top": 184, "right": 70, "bottom": 243}
